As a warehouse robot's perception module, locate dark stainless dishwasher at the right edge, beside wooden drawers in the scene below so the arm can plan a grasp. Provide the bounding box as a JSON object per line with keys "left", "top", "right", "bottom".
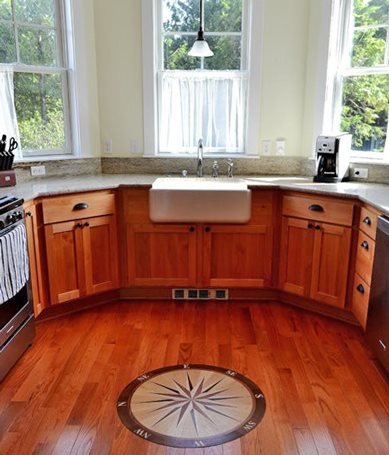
{"left": 366, "top": 216, "right": 389, "bottom": 372}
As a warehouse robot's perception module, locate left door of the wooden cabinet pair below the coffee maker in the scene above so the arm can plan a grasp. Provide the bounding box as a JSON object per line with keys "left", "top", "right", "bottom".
{"left": 280, "top": 217, "right": 315, "bottom": 297}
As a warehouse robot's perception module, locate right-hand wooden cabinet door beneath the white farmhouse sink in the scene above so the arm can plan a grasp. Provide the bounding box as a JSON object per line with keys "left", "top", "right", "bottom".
{"left": 202, "top": 225, "right": 273, "bottom": 288}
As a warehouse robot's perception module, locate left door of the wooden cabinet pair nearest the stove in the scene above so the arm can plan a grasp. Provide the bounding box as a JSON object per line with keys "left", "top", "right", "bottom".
{"left": 45, "top": 221, "right": 85, "bottom": 305}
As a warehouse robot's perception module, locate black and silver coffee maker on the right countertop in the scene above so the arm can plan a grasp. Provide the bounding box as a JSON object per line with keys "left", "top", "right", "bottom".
{"left": 313, "top": 133, "right": 351, "bottom": 183}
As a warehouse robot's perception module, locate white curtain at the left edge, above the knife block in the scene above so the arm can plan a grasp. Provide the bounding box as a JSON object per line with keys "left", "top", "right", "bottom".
{"left": 0, "top": 65, "right": 20, "bottom": 157}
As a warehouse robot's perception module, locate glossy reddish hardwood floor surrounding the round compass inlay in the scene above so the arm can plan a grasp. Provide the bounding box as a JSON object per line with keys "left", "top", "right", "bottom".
{"left": 0, "top": 301, "right": 389, "bottom": 455}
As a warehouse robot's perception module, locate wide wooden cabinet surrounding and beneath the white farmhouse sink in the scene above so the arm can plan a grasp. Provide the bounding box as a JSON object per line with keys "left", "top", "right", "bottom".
{"left": 121, "top": 189, "right": 275, "bottom": 288}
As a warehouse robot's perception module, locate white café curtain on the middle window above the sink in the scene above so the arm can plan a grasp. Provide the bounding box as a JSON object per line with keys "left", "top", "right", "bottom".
{"left": 158, "top": 71, "right": 247, "bottom": 153}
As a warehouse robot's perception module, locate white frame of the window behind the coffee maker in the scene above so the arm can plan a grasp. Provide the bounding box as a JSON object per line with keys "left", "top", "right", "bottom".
{"left": 322, "top": 0, "right": 389, "bottom": 161}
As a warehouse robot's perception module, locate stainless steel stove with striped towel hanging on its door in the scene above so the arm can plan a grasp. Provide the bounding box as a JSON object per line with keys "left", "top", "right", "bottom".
{"left": 0, "top": 196, "right": 35, "bottom": 381}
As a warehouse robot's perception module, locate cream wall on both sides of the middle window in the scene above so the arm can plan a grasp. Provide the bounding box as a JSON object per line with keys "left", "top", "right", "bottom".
{"left": 94, "top": 0, "right": 327, "bottom": 156}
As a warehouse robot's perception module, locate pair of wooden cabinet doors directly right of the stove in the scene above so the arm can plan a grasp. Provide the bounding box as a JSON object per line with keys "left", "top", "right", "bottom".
{"left": 45, "top": 215, "right": 118, "bottom": 305}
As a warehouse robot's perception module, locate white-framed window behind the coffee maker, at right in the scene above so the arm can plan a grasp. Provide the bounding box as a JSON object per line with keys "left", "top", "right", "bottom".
{"left": 329, "top": 0, "right": 389, "bottom": 158}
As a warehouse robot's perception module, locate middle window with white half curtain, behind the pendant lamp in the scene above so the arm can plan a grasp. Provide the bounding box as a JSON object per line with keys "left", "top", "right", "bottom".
{"left": 143, "top": 0, "right": 261, "bottom": 155}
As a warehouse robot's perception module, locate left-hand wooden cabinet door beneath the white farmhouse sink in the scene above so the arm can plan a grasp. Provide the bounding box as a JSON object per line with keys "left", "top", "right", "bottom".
{"left": 127, "top": 224, "right": 197, "bottom": 287}
